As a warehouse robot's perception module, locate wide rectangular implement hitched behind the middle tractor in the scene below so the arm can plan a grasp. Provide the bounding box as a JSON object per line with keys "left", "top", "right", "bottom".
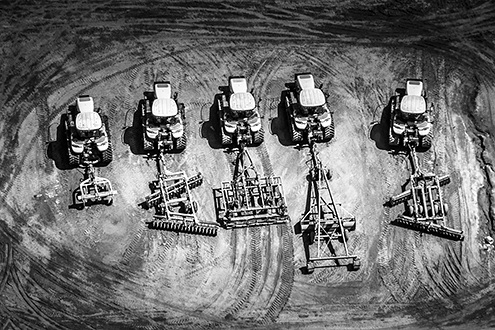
{"left": 213, "top": 144, "right": 289, "bottom": 229}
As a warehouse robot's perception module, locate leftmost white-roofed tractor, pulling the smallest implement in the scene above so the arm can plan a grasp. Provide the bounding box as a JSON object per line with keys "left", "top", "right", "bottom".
{"left": 65, "top": 95, "right": 113, "bottom": 167}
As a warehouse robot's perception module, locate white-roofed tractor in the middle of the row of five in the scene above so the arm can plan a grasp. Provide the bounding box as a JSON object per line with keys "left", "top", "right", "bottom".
{"left": 217, "top": 76, "right": 264, "bottom": 147}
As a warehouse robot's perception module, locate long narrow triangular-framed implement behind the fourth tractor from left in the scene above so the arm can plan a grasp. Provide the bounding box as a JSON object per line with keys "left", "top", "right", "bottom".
{"left": 301, "top": 141, "right": 361, "bottom": 273}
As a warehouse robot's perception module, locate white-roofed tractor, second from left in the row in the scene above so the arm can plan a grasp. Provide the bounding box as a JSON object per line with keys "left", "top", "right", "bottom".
{"left": 141, "top": 81, "right": 186, "bottom": 151}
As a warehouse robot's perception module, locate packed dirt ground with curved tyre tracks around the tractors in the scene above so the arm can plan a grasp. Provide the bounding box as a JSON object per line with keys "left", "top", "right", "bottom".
{"left": 0, "top": 0, "right": 495, "bottom": 330}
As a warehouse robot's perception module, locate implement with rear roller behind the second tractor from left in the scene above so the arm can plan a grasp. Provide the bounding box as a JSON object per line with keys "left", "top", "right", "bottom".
{"left": 143, "top": 153, "right": 218, "bottom": 236}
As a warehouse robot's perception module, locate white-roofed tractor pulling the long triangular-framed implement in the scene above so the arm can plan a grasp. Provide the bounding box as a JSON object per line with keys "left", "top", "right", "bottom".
{"left": 283, "top": 73, "right": 335, "bottom": 143}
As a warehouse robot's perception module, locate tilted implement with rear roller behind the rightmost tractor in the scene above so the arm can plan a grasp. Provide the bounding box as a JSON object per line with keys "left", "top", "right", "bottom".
{"left": 387, "top": 144, "right": 464, "bottom": 241}
